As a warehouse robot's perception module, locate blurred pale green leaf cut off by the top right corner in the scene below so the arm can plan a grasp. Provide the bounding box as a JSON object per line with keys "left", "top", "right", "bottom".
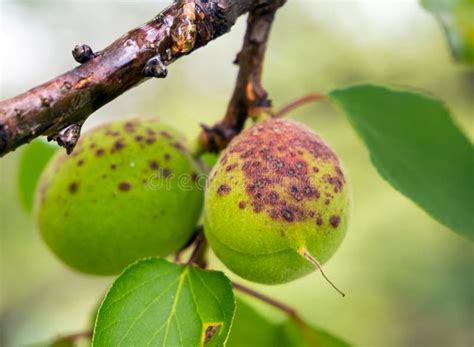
{"left": 421, "top": 0, "right": 474, "bottom": 65}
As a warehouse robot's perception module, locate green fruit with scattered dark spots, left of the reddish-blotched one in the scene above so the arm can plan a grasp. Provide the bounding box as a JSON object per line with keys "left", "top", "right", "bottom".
{"left": 35, "top": 120, "right": 203, "bottom": 275}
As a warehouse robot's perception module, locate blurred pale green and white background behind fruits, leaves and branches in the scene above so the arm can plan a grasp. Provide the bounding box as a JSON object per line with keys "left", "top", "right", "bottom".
{"left": 0, "top": 0, "right": 474, "bottom": 347}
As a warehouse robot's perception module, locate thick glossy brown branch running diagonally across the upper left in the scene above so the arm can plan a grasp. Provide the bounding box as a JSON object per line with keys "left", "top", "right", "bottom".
{"left": 0, "top": 0, "right": 282, "bottom": 156}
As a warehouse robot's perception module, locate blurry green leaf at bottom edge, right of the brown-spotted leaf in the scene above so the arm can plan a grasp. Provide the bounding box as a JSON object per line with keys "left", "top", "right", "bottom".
{"left": 226, "top": 299, "right": 350, "bottom": 347}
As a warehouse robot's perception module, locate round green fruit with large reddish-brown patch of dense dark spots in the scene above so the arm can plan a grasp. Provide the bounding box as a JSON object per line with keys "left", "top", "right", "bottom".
{"left": 204, "top": 119, "right": 349, "bottom": 284}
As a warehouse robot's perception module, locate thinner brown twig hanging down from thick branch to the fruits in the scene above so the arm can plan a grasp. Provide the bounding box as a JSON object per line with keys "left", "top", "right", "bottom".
{"left": 200, "top": 0, "right": 286, "bottom": 152}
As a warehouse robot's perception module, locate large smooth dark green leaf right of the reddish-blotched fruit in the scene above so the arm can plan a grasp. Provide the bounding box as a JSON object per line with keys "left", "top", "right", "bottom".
{"left": 330, "top": 85, "right": 474, "bottom": 240}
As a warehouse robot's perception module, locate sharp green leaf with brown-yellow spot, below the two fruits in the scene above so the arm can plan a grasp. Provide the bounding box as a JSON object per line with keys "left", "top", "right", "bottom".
{"left": 93, "top": 258, "right": 235, "bottom": 347}
